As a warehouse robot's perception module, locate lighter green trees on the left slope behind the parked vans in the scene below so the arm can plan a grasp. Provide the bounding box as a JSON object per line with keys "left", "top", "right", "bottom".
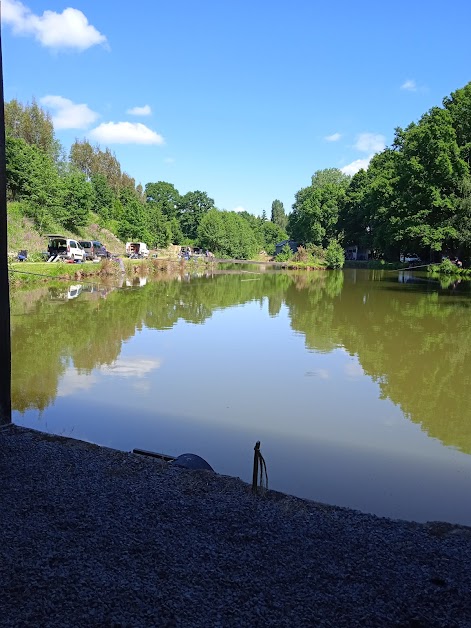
{"left": 5, "top": 100, "right": 288, "bottom": 259}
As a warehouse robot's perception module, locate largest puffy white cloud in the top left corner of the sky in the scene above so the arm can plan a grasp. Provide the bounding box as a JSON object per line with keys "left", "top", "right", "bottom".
{"left": 2, "top": 0, "right": 107, "bottom": 51}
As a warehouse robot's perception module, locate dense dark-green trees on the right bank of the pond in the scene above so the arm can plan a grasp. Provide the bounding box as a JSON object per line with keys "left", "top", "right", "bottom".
{"left": 288, "top": 83, "right": 471, "bottom": 261}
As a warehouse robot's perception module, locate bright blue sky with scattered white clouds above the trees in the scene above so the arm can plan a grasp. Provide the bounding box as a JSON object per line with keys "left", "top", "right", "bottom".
{"left": 1, "top": 0, "right": 471, "bottom": 216}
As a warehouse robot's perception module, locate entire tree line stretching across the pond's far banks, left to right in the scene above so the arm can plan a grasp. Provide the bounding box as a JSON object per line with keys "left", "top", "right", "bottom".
{"left": 5, "top": 83, "right": 471, "bottom": 265}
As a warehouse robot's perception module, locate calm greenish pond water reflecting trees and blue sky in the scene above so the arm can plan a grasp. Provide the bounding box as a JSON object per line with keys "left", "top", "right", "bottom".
{"left": 11, "top": 266, "right": 471, "bottom": 525}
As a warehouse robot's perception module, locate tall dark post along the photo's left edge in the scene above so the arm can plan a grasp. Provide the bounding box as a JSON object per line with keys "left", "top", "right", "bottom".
{"left": 0, "top": 2, "right": 11, "bottom": 425}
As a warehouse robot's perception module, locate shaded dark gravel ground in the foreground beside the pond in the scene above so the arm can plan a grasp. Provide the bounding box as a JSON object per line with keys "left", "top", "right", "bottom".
{"left": 0, "top": 426, "right": 471, "bottom": 628}
